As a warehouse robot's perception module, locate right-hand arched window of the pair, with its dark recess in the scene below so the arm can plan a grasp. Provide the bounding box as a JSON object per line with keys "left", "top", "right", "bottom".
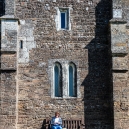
{"left": 68, "top": 63, "right": 77, "bottom": 97}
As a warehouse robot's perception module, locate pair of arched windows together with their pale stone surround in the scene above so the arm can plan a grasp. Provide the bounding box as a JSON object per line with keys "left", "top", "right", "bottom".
{"left": 48, "top": 59, "right": 81, "bottom": 99}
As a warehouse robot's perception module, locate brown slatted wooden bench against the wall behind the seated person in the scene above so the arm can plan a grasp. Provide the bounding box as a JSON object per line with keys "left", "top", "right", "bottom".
{"left": 44, "top": 119, "right": 85, "bottom": 129}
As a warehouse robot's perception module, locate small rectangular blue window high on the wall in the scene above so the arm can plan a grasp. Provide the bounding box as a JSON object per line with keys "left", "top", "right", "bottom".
{"left": 60, "top": 9, "right": 69, "bottom": 29}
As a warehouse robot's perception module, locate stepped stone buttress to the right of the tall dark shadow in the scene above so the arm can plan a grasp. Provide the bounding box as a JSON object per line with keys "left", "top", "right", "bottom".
{"left": 110, "top": 0, "right": 128, "bottom": 129}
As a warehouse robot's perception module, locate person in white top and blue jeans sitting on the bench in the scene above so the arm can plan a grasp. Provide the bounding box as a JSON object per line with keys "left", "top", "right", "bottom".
{"left": 51, "top": 112, "right": 62, "bottom": 129}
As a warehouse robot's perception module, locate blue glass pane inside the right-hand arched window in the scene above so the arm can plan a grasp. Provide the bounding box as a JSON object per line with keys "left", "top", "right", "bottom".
{"left": 69, "top": 66, "right": 74, "bottom": 97}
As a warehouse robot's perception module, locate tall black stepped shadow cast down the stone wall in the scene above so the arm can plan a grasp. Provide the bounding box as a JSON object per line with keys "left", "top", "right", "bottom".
{"left": 82, "top": 0, "right": 114, "bottom": 129}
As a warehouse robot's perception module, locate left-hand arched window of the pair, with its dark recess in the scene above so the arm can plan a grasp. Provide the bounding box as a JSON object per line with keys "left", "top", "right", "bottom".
{"left": 54, "top": 62, "right": 62, "bottom": 97}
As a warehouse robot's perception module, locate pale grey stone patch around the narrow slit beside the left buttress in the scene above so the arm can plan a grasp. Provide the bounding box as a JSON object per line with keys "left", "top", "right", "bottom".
{"left": 18, "top": 20, "right": 36, "bottom": 63}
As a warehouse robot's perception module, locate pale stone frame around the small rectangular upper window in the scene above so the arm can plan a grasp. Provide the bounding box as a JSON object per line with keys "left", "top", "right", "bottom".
{"left": 55, "top": 7, "right": 72, "bottom": 31}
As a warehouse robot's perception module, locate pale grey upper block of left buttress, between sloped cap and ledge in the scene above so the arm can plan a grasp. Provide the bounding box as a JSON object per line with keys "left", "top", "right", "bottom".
{"left": 1, "top": 19, "right": 18, "bottom": 51}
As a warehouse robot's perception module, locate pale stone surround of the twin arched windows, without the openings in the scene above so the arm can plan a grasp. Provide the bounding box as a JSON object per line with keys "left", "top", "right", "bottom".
{"left": 48, "top": 59, "right": 81, "bottom": 99}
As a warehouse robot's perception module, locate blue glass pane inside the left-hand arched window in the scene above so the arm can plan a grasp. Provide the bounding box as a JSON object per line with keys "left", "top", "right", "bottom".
{"left": 54, "top": 66, "right": 59, "bottom": 97}
